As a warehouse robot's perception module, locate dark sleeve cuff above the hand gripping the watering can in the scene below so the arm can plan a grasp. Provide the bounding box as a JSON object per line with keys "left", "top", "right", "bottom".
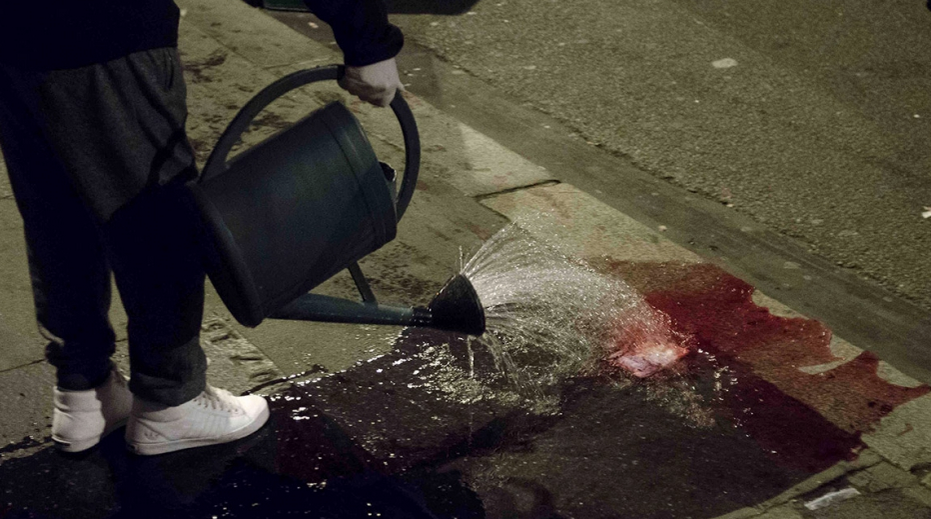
{"left": 304, "top": 0, "right": 404, "bottom": 67}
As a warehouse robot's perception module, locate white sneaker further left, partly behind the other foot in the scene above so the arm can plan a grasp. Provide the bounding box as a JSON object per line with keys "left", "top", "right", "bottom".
{"left": 52, "top": 365, "right": 133, "bottom": 452}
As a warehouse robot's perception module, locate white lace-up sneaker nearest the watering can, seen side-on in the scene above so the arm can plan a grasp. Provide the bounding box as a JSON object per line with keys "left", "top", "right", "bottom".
{"left": 126, "top": 386, "right": 268, "bottom": 456}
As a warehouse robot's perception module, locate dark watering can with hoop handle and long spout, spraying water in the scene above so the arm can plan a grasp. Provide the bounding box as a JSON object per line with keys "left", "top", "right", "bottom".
{"left": 188, "top": 65, "right": 485, "bottom": 335}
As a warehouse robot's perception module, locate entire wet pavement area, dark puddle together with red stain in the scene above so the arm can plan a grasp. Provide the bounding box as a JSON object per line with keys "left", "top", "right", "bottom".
{"left": 0, "top": 264, "right": 928, "bottom": 519}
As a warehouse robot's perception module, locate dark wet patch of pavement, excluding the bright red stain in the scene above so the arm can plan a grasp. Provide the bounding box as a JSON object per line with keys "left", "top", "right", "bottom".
{"left": 0, "top": 355, "right": 806, "bottom": 518}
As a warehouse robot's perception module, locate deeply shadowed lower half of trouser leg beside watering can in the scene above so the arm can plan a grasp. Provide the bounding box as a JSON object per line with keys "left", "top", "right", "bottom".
{"left": 103, "top": 182, "right": 207, "bottom": 406}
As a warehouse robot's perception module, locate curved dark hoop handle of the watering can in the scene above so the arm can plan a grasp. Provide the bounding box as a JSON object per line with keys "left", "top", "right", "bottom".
{"left": 206, "top": 65, "right": 420, "bottom": 219}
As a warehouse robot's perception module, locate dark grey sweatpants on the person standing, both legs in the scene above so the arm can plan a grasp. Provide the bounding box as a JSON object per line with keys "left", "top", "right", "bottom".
{"left": 0, "top": 48, "right": 206, "bottom": 405}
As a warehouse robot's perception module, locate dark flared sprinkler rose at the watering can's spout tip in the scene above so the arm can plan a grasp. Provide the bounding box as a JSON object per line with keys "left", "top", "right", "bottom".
{"left": 427, "top": 274, "right": 485, "bottom": 336}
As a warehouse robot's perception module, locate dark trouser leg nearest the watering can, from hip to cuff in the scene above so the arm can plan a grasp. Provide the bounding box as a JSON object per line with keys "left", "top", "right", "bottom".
{"left": 12, "top": 48, "right": 207, "bottom": 405}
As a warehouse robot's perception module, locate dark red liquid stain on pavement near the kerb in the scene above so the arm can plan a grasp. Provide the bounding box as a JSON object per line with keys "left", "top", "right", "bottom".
{"left": 603, "top": 262, "right": 929, "bottom": 472}
